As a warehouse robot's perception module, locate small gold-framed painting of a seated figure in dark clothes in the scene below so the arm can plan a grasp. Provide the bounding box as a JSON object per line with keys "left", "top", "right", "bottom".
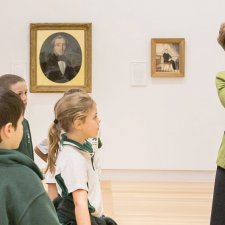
{"left": 151, "top": 38, "right": 185, "bottom": 77}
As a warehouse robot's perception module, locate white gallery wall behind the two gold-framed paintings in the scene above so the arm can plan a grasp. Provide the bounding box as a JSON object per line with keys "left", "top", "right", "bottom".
{"left": 0, "top": 0, "right": 225, "bottom": 173}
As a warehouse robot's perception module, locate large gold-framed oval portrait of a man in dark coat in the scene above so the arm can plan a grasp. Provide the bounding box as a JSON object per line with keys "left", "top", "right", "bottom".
{"left": 30, "top": 23, "right": 92, "bottom": 92}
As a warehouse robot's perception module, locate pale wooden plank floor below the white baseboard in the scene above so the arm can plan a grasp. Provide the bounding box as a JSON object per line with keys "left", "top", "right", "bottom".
{"left": 101, "top": 181, "right": 213, "bottom": 225}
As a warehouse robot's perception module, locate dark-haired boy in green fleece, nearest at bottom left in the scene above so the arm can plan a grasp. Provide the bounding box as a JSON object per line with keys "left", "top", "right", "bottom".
{"left": 0, "top": 88, "right": 60, "bottom": 225}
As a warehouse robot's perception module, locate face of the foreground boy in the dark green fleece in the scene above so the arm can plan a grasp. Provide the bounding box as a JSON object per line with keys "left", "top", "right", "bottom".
{"left": 10, "top": 116, "right": 24, "bottom": 149}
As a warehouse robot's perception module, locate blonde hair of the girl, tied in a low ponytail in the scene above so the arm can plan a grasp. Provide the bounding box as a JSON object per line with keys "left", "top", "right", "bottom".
{"left": 46, "top": 92, "right": 94, "bottom": 173}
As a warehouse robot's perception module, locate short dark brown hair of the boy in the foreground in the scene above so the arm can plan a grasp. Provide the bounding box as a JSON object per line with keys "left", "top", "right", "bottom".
{"left": 0, "top": 87, "right": 25, "bottom": 142}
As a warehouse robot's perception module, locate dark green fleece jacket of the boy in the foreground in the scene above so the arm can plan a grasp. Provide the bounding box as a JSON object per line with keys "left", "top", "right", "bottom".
{"left": 0, "top": 149, "right": 60, "bottom": 225}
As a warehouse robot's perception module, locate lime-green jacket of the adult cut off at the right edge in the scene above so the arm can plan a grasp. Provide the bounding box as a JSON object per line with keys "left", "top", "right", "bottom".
{"left": 216, "top": 71, "right": 225, "bottom": 169}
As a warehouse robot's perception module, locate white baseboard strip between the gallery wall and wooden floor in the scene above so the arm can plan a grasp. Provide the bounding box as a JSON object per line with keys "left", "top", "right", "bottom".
{"left": 100, "top": 169, "right": 215, "bottom": 182}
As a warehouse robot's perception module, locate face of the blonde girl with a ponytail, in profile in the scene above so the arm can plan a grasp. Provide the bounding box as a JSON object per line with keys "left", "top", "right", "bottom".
{"left": 82, "top": 104, "right": 100, "bottom": 139}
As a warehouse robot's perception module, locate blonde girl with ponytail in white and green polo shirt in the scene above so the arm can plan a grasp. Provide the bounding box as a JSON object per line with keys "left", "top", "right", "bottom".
{"left": 47, "top": 93, "right": 116, "bottom": 225}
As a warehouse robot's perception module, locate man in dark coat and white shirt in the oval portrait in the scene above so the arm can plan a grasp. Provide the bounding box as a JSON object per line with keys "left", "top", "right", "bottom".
{"left": 40, "top": 35, "right": 80, "bottom": 83}
